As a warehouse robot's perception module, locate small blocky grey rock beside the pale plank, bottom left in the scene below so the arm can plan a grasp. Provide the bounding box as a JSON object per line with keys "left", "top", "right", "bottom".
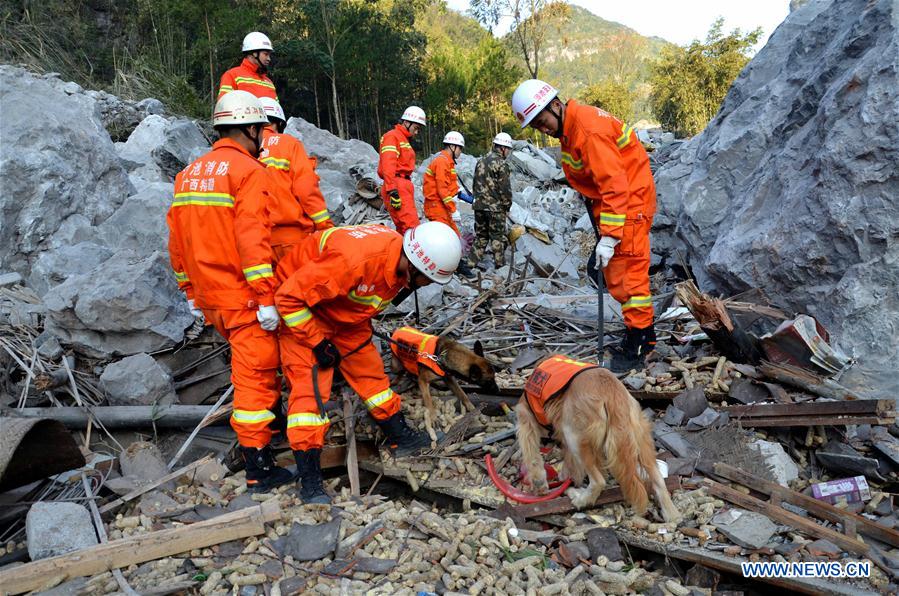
{"left": 25, "top": 502, "right": 99, "bottom": 561}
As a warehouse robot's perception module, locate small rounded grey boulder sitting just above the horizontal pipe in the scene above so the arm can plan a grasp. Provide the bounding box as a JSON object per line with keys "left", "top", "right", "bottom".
{"left": 100, "top": 352, "right": 176, "bottom": 406}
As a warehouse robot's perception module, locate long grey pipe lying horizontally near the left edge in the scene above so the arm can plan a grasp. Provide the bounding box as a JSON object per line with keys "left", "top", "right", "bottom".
{"left": 3, "top": 404, "right": 222, "bottom": 430}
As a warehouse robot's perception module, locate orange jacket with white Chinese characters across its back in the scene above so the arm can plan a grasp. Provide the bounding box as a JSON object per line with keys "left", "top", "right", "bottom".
{"left": 166, "top": 139, "right": 275, "bottom": 309}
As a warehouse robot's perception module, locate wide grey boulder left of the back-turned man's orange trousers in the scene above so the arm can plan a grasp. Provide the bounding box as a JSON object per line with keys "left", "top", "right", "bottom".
{"left": 44, "top": 250, "right": 193, "bottom": 358}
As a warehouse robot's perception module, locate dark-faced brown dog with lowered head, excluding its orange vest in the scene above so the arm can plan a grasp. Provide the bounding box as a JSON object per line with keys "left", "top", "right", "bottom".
{"left": 391, "top": 336, "right": 496, "bottom": 441}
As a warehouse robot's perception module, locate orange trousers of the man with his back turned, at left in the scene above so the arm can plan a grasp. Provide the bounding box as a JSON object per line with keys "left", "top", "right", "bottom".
{"left": 204, "top": 310, "right": 281, "bottom": 448}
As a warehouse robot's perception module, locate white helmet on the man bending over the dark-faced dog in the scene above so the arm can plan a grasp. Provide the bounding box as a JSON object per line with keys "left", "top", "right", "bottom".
{"left": 403, "top": 221, "right": 462, "bottom": 285}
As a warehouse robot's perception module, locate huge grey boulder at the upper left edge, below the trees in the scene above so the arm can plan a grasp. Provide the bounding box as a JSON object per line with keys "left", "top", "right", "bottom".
{"left": 0, "top": 66, "right": 134, "bottom": 276}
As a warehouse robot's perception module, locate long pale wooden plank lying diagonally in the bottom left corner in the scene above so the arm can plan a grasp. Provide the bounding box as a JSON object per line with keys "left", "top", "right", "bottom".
{"left": 0, "top": 498, "right": 281, "bottom": 594}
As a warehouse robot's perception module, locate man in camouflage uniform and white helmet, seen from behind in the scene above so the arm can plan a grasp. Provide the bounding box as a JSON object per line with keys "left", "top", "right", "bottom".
{"left": 472, "top": 132, "right": 512, "bottom": 269}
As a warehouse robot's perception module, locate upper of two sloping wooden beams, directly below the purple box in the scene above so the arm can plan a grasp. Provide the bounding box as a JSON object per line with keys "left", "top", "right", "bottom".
{"left": 714, "top": 462, "right": 899, "bottom": 546}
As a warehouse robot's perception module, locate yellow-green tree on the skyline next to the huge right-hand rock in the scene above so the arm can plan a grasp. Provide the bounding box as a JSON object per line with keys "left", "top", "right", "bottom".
{"left": 650, "top": 18, "right": 762, "bottom": 136}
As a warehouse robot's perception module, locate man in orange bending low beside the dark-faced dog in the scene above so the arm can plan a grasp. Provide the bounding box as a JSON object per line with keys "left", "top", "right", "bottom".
{"left": 275, "top": 222, "right": 462, "bottom": 503}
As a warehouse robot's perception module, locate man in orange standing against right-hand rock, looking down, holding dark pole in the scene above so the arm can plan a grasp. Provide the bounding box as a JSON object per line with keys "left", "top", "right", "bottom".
{"left": 512, "top": 79, "right": 656, "bottom": 372}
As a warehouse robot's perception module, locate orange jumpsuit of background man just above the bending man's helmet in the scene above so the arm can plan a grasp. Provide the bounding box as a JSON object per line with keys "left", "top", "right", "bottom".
{"left": 378, "top": 124, "right": 420, "bottom": 234}
